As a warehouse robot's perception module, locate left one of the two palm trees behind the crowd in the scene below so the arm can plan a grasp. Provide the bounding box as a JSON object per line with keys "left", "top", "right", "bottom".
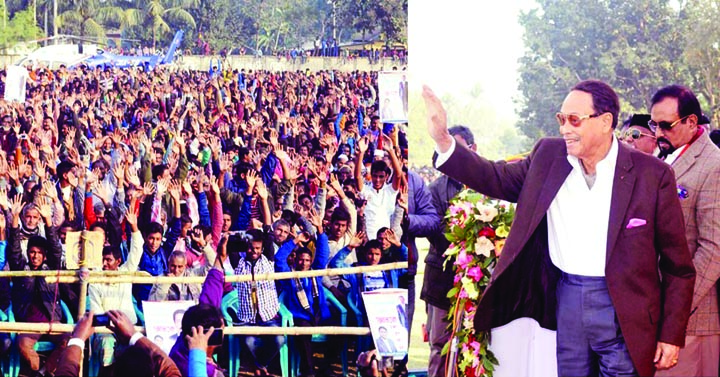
{"left": 55, "top": 0, "right": 137, "bottom": 38}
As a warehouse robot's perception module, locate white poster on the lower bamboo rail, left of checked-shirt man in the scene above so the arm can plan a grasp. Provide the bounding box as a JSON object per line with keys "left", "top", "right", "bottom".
{"left": 143, "top": 301, "right": 196, "bottom": 354}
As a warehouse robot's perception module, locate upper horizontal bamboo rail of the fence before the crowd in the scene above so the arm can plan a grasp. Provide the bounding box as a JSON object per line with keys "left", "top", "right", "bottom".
{"left": 42, "top": 262, "right": 408, "bottom": 284}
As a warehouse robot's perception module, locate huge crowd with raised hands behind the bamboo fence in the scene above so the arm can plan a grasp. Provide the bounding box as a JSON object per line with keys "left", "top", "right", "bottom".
{"left": 0, "top": 63, "right": 414, "bottom": 377}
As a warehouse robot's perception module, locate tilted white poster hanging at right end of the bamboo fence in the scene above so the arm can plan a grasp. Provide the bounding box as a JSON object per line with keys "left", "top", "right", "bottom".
{"left": 362, "top": 288, "right": 408, "bottom": 359}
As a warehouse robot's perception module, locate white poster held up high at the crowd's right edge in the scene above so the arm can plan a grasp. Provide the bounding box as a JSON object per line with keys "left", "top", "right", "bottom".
{"left": 378, "top": 71, "right": 408, "bottom": 123}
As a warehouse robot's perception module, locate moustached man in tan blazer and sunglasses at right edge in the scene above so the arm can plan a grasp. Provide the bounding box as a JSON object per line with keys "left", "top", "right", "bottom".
{"left": 649, "top": 85, "right": 720, "bottom": 376}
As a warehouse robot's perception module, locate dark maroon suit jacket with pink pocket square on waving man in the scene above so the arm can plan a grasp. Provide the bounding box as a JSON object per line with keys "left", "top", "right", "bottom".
{"left": 439, "top": 139, "right": 695, "bottom": 376}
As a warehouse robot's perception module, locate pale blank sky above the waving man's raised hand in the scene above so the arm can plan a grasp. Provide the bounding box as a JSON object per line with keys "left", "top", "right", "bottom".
{"left": 408, "top": 0, "right": 535, "bottom": 119}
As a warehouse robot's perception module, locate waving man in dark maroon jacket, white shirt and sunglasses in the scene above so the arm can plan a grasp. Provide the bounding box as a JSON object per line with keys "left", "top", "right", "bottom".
{"left": 423, "top": 80, "right": 695, "bottom": 376}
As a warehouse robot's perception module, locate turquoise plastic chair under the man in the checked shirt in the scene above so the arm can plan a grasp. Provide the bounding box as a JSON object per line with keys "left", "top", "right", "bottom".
{"left": 220, "top": 290, "right": 292, "bottom": 377}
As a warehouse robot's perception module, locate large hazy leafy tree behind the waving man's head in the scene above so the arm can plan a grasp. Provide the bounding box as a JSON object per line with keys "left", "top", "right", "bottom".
{"left": 519, "top": 0, "right": 689, "bottom": 141}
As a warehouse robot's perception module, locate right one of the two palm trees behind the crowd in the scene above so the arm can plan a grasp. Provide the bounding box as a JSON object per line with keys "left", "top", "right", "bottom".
{"left": 139, "top": 0, "right": 199, "bottom": 49}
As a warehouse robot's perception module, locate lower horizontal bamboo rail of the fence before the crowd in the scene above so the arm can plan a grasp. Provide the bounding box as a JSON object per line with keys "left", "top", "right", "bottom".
{"left": 0, "top": 322, "right": 370, "bottom": 336}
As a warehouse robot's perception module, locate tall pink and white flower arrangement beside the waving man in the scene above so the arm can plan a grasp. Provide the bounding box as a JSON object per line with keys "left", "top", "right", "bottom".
{"left": 443, "top": 189, "right": 515, "bottom": 377}
